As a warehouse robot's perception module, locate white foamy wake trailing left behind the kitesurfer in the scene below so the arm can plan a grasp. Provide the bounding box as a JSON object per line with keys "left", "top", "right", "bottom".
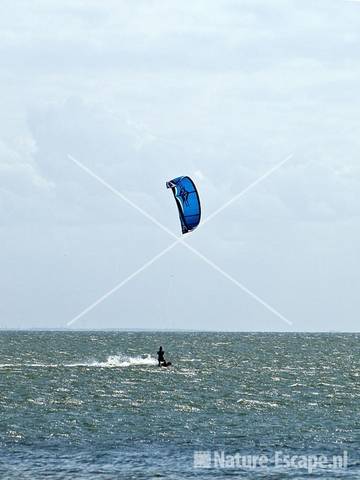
{"left": 0, "top": 355, "right": 157, "bottom": 369}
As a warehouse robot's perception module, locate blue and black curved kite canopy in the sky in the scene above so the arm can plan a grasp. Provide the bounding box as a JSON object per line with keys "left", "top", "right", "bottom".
{"left": 166, "top": 177, "right": 201, "bottom": 233}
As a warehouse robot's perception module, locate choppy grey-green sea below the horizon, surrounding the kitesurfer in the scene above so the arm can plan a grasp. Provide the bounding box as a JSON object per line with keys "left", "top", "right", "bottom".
{"left": 0, "top": 331, "right": 360, "bottom": 480}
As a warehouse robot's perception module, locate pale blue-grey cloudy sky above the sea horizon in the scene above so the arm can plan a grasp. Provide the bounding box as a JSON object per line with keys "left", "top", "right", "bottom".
{"left": 0, "top": 0, "right": 360, "bottom": 331}
